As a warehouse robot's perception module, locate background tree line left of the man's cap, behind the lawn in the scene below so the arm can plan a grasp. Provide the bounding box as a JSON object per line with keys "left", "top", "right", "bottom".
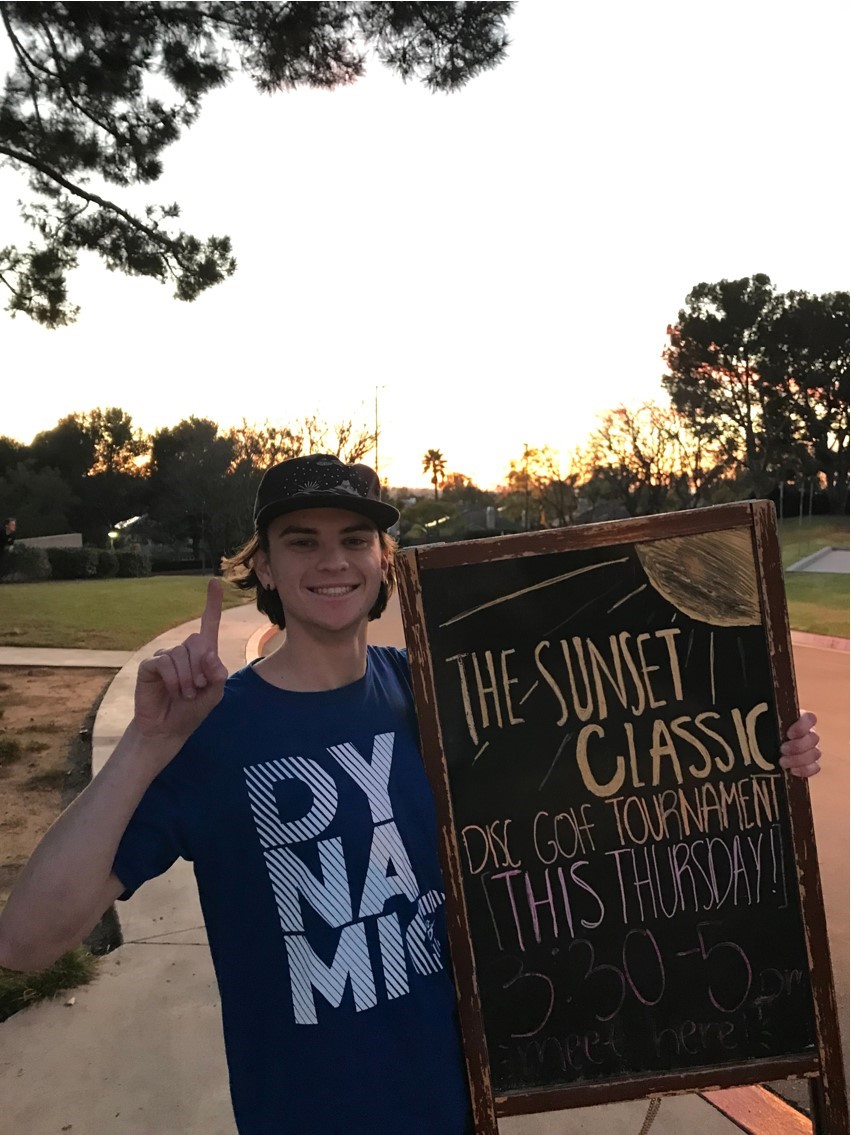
{"left": 0, "top": 406, "right": 374, "bottom": 566}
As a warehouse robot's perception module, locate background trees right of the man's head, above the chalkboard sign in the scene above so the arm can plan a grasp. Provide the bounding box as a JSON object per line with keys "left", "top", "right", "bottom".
{"left": 419, "top": 275, "right": 849, "bottom": 538}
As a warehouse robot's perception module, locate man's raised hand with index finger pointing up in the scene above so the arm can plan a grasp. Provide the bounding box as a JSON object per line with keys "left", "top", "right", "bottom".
{"left": 134, "top": 579, "right": 227, "bottom": 747}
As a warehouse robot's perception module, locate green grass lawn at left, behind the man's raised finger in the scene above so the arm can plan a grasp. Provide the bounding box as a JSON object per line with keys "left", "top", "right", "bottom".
{"left": 0, "top": 575, "right": 244, "bottom": 650}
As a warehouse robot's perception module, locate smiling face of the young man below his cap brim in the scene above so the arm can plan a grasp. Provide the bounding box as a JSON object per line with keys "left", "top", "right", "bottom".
{"left": 254, "top": 508, "right": 388, "bottom": 634}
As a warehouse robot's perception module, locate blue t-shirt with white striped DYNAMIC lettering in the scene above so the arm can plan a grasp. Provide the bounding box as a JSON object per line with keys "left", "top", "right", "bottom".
{"left": 115, "top": 647, "right": 469, "bottom": 1135}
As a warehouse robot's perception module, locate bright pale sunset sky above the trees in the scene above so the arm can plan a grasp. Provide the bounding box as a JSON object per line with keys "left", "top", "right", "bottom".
{"left": 0, "top": 0, "right": 851, "bottom": 487}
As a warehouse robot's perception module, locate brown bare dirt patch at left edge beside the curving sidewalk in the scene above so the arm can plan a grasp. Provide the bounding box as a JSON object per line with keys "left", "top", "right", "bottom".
{"left": 0, "top": 666, "right": 118, "bottom": 953}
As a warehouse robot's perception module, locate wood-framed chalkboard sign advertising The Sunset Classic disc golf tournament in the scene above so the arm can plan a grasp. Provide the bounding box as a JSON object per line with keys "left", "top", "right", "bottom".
{"left": 399, "top": 503, "right": 846, "bottom": 1133}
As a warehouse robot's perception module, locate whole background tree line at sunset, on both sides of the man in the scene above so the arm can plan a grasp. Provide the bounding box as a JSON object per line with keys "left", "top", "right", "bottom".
{"left": 0, "top": 275, "right": 849, "bottom": 565}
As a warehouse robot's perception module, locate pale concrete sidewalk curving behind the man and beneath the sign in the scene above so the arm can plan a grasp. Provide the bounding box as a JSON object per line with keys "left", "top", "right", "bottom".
{"left": 0, "top": 605, "right": 835, "bottom": 1135}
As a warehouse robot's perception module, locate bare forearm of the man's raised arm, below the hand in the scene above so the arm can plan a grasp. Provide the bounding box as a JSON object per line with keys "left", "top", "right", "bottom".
{"left": 0, "top": 725, "right": 179, "bottom": 969}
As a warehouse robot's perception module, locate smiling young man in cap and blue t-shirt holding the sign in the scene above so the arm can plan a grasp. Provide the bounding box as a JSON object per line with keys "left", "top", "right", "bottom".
{"left": 0, "top": 455, "right": 819, "bottom": 1135}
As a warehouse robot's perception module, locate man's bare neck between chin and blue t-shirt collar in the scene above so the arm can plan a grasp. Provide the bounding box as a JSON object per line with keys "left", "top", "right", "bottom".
{"left": 254, "top": 622, "right": 366, "bottom": 693}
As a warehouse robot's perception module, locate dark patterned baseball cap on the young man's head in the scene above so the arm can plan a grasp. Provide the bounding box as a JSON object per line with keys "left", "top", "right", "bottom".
{"left": 254, "top": 453, "right": 399, "bottom": 531}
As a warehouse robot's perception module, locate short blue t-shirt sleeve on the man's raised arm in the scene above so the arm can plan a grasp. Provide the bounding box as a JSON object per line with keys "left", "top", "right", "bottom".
{"left": 112, "top": 758, "right": 191, "bottom": 899}
